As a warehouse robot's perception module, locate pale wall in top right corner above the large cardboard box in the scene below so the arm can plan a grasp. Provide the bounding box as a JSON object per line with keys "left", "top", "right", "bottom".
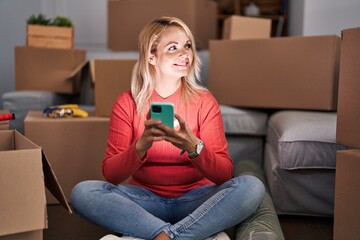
{"left": 289, "top": 0, "right": 360, "bottom": 36}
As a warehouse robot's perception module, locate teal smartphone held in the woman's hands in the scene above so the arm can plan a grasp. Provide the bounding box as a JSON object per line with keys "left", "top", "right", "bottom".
{"left": 150, "top": 102, "right": 174, "bottom": 128}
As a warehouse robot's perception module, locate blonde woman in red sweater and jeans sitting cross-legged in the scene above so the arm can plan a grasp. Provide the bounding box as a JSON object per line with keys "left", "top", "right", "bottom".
{"left": 71, "top": 17, "right": 264, "bottom": 240}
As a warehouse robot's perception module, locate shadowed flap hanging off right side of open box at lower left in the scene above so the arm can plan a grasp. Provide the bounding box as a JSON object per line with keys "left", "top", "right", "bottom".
{"left": 42, "top": 151, "right": 73, "bottom": 214}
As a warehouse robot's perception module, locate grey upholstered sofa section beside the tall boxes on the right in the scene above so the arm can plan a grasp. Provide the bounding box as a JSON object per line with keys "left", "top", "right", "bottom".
{"left": 264, "top": 110, "right": 348, "bottom": 216}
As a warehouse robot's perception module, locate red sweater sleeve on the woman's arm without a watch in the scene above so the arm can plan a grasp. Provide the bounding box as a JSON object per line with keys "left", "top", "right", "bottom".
{"left": 102, "top": 92, "right": 146, "bottom": 184}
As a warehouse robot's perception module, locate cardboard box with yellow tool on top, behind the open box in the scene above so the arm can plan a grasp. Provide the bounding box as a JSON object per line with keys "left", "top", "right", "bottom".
{"left": 24, "top": 111, "right": 109, "bottom": 204}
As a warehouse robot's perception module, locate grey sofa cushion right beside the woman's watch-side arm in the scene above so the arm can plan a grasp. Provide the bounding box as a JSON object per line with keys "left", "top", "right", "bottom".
{"left": 220, "top": 105, "right": 268, "bottom": 136}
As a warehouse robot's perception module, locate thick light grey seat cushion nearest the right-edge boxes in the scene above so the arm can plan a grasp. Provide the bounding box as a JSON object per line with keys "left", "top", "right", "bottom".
{"left": 267, "top": 111, "right": 347, "bottom": 169}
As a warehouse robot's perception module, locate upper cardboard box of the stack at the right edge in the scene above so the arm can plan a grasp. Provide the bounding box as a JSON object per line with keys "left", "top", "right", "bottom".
{"left": 336, "top": 28, "right": 360, "bottom": 148}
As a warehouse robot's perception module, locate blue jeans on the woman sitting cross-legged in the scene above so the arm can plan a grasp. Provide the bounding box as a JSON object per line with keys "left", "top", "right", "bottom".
{"left": 70, "top": 176, "right": 265, "bottom": 240}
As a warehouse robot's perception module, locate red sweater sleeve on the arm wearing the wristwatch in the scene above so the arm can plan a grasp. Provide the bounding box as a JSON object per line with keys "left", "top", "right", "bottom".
{"left": 190, "top": 93, "right": 233, "bottom": 184}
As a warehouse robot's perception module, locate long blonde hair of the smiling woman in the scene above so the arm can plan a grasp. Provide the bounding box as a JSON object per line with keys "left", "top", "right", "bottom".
{"left": 131, "top": 17, "right": 206, "bottom": 115}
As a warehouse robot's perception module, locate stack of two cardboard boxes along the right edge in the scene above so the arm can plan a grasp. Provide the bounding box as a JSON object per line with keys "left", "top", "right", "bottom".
{"left": 334, "top": 28, "right": 360, "bottom": 240}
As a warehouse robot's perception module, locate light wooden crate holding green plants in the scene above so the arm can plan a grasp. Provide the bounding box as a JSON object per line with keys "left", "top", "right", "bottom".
{"left": 26, "top": 24, "right": 74, "bottom": 49}
